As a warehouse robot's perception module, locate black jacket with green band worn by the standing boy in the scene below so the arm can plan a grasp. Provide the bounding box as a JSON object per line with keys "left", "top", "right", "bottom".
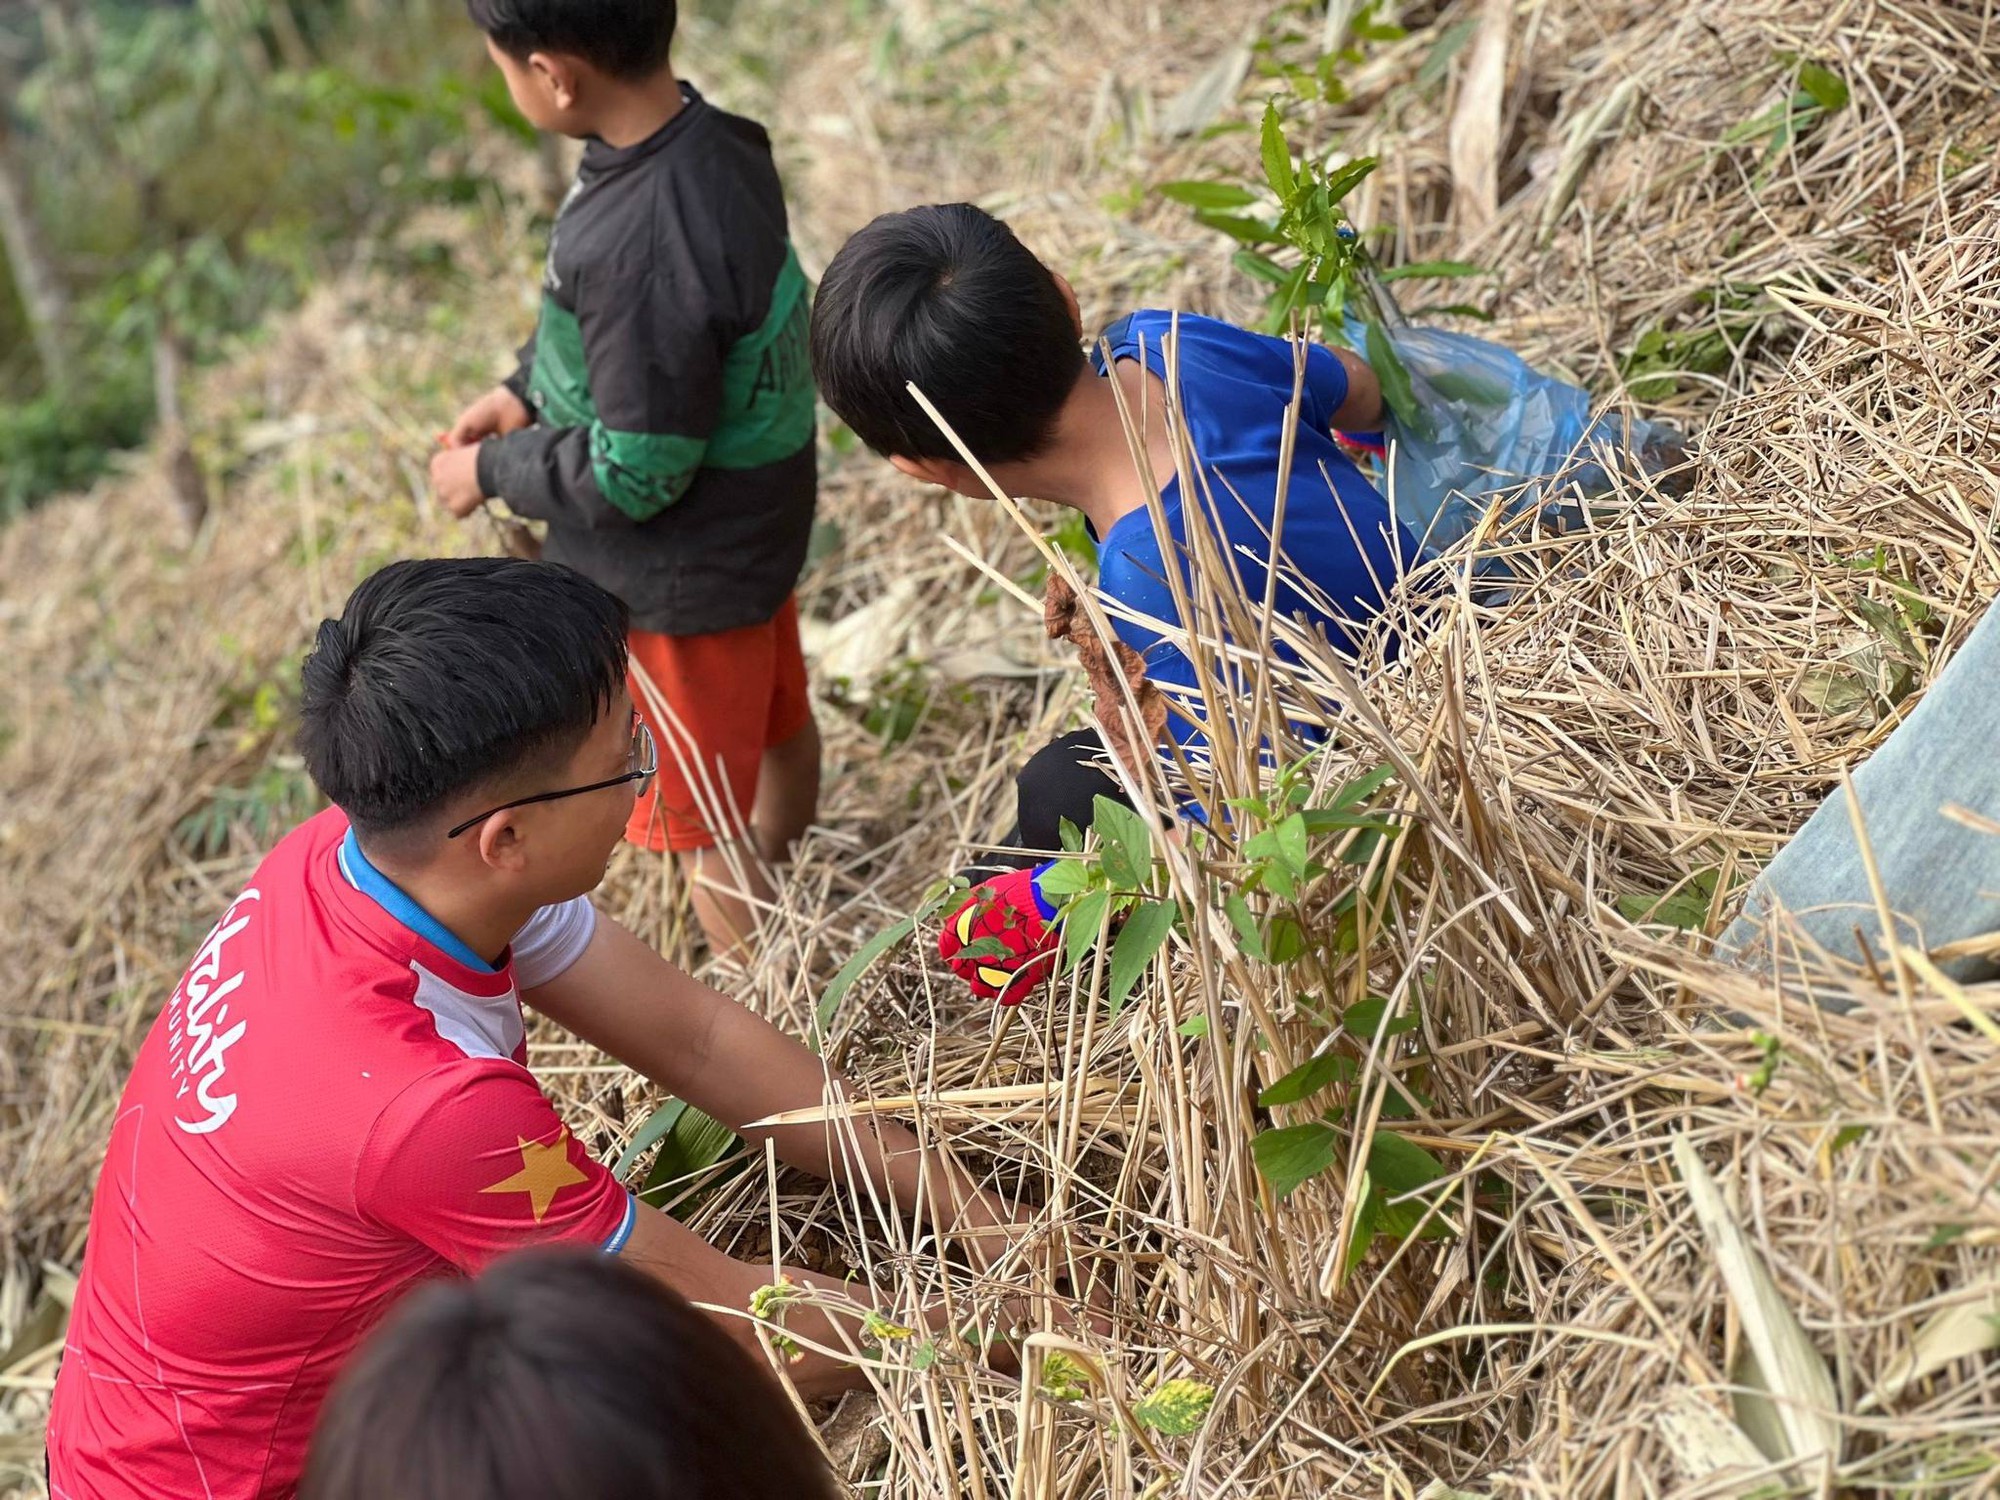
{"left": 480, "top": 86, "right": 816, "bottom": 636}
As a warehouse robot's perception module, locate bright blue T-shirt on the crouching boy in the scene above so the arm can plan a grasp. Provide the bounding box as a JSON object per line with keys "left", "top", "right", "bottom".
{"left": 1094, "top": 310, "right": 1418, "bottom": 748}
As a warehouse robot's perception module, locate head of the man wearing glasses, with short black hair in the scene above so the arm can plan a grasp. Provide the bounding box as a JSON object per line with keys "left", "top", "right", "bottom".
{"left": 300, "top": 558, "right": 656, "bottom": 926}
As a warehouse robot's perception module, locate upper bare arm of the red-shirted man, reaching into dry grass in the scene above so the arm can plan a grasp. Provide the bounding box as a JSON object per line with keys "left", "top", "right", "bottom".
{"left": 526, "top": 914, "right": 1012, "bottom": 1260}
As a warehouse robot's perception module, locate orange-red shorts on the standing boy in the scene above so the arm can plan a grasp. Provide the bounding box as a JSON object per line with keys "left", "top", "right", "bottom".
{"left": 626, "top": 596, "right": 812, "bottom": 852}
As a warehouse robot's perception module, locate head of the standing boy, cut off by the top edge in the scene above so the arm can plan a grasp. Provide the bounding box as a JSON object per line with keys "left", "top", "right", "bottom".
{"left": 466, "top": 0, "right": 678, "bottom": 138}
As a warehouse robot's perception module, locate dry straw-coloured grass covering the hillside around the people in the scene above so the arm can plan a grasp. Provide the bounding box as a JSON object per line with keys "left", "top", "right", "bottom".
{"left": 0, "top": 0, "right": 2000, "bottom": 1500}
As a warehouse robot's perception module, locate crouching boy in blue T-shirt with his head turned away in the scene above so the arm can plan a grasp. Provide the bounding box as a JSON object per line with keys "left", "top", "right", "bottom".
{"left": 812, "top": 204, "right": 1418, "bottom": 1002}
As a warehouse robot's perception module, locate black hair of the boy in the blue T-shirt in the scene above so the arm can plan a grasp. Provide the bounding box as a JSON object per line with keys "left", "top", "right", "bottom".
{"left": 812, "top": 204, "right": 1088, "bottom": 464}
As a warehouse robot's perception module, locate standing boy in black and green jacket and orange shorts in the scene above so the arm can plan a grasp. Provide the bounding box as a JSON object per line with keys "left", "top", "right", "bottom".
{"left": 432, "top": 0, "right": 820, "bottom": 964}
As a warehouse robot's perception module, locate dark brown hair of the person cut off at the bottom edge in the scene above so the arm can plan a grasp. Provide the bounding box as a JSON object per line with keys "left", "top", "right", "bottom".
{"left": 298, "top": 1250, "right": 836, "bottom": 1500}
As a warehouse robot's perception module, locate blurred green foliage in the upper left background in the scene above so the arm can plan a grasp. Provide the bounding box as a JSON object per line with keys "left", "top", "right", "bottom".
{"left": 0, "top": 0, "right": 532, "bottom": 518}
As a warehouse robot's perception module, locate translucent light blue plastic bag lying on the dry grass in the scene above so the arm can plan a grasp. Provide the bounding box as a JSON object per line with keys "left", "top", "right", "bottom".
{"left": 1346, "top": 316, "right": 1686, "bottom": 576}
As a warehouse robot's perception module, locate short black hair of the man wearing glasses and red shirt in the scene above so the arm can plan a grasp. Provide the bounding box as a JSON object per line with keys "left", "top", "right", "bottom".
{"left": 298, "top": 558, "right": 626, "bottom": 836}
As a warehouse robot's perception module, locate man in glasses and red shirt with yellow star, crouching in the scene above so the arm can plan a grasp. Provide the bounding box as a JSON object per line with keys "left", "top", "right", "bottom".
{"left": 48, "top": 558, "right": 1006, "bottom": 1500}
